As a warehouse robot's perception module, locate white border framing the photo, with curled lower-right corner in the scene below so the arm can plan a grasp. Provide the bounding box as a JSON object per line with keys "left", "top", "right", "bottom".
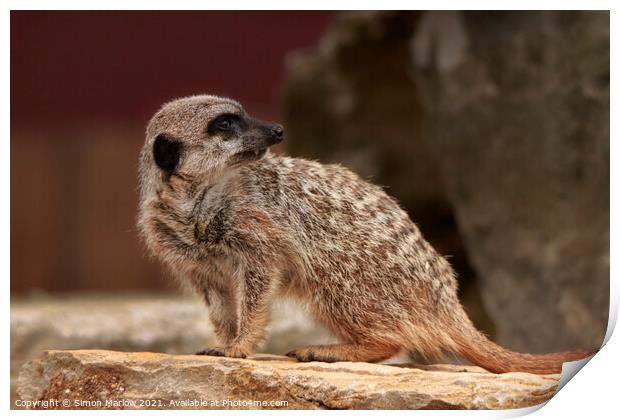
{"left": 0, "top": 0, "right": 620, "bottom": 420}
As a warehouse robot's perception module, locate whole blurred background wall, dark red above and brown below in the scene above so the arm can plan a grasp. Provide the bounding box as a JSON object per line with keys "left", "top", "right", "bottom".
{"left": 11, "top": 11, "right": 333, "bottom": 293}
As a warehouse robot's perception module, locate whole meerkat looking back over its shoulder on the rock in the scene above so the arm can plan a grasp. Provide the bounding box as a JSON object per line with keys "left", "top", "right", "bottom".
{"left": 138, "top": 95, "right": 591, "bottom": 374}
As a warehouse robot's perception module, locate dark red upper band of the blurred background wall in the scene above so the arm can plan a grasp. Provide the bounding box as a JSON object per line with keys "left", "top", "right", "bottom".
{"left": 11, "top": 11, "right": 332, "bottom": 123}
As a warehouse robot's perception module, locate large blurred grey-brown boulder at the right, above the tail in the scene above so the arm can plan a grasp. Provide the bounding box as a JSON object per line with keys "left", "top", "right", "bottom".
{"left": 411, "top": 12, "right": 610, "bottom": 352}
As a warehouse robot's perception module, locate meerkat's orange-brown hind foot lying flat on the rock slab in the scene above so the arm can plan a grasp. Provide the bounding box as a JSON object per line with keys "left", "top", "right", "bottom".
{"left": 286, "top": 343, "right": 401, "bottom": 363}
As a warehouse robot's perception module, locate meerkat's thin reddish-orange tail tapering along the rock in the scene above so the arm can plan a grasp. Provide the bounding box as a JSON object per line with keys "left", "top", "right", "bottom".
{"left": 448, "top": 305, "right": 596, "bottom": 374}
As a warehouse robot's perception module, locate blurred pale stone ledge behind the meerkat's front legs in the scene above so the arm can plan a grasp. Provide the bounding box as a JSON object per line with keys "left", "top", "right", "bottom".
{"left": 11, "top": 294, "right": 334, "bottom": 406}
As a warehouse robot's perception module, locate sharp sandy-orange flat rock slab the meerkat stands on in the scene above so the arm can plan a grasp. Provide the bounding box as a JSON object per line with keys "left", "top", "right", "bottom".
{"left": 18, "top": 350, "right": 559, "bottom": 409}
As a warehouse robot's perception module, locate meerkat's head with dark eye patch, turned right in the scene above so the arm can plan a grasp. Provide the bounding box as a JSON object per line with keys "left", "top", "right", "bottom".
{"left": 140, "top": 95, "right": 284, "bottom": 199}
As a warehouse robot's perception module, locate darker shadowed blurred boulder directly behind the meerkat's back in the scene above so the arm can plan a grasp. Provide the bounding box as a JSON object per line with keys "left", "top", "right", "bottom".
{"left": 282, "top": 12, "right": 493, "bottom": 333}
